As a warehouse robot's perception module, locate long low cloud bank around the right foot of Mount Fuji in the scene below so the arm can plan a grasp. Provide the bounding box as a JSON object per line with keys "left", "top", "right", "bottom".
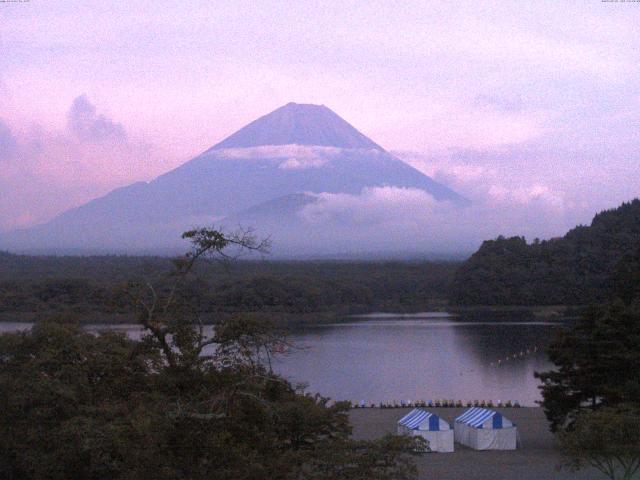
{"left": 256, "top": 185, "right": 574, "bottom": 255}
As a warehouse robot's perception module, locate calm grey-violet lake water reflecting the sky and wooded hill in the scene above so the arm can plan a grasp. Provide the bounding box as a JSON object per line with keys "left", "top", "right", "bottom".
{"left": 0, "top": 313, "right": 559, "bottom": 406}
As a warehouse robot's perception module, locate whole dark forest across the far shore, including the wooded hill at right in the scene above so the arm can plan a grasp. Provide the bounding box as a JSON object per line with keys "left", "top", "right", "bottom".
{"left": 0, "top": 199, "right": 640, "bottom": 316}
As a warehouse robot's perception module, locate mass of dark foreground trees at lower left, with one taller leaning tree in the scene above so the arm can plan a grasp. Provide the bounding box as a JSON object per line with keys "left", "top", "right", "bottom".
{"left": 0, "top": 229, "right": 417, "bottom": 480}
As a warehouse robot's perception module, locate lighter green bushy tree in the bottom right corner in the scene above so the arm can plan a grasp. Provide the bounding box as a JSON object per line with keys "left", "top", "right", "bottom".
{"left": 559, "top": 406, "right": 640, "bottom": 480}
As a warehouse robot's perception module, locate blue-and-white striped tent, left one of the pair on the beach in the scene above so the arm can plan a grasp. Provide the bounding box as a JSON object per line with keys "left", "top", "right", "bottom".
{"left": 398, "top": 408, "right": 453, "bottom": 452}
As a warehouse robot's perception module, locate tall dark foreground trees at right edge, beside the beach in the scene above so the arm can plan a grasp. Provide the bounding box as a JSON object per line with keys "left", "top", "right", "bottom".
{"left": 537, "top": 248, "right": 640, "bottom": 480}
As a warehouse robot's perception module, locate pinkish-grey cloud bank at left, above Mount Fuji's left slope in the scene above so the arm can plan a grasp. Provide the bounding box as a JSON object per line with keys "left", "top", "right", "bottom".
{"left": 0, "top": 95, "right": 168, "bottom": 231}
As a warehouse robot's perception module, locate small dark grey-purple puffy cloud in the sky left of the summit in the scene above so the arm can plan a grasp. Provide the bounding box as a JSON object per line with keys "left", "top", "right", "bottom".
{"left": 67, "top": 95, "right": 127, "bottom": 142}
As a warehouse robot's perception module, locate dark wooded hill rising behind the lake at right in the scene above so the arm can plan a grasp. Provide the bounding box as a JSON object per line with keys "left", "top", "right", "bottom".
{"left": 450, "top": 199, "right": 640, "bottom": 305}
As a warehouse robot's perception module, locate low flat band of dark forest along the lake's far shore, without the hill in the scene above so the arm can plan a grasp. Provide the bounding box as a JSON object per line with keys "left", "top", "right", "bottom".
{"left": 0, "top": 253, "right": 457, "bottom": 323}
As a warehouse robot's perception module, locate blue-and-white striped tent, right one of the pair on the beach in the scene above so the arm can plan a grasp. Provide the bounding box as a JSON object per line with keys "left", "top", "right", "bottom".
{"left": 453, "top": 407, "right": 518, "bottom": 450}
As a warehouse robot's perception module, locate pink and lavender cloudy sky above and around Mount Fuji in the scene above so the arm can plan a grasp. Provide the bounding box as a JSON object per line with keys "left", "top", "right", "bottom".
{"left": 0, "top": 0, "right": 640, "bottom": 236}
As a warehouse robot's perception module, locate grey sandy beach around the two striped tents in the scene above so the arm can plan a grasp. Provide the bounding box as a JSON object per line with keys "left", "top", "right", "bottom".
{"left": 349, "top": 408, "right": 604, "bottom": 480}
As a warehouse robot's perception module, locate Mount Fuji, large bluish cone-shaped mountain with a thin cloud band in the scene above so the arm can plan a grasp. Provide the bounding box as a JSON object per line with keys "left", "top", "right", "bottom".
{"left": 0, "top": 103, "right": 469, "bottom": 253}
